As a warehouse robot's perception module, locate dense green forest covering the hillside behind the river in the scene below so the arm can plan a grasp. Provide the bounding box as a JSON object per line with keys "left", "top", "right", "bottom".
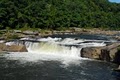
{"left": 0, "top": 0, "right": 120, "bottom": 29}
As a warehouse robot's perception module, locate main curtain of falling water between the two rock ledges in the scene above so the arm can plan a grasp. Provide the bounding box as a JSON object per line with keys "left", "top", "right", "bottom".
{"left": 26, "top": 42, "right": 81, "bottom": 56}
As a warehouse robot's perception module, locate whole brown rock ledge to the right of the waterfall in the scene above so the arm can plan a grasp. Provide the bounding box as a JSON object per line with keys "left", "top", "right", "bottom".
{"left": 81, "top": 43, "right": 120, "bottom": 62}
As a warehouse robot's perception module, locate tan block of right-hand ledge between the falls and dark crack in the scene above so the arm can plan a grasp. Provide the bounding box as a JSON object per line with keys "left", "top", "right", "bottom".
{"left": 81, "top": 47, "right": 101, "bottom": 59}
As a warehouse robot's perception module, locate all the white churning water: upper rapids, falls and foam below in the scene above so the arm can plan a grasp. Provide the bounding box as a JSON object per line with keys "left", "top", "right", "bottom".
{"left": 5, "top": 37, "right": 106, "bottom": 64}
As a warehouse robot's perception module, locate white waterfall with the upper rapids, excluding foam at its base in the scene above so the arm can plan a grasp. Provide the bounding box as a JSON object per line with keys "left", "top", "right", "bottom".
{"left": 6, "top": 37, "right": 106, "bottom": 57}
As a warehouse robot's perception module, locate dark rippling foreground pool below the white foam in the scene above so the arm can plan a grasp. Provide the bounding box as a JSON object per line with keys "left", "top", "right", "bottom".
{"left": 0, "top": 54, "right": 119, "bottom": 80}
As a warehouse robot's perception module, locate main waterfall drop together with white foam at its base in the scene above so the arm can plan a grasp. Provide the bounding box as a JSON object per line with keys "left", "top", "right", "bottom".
{"left": 5, "top": 42, "right": 82, "bottom": 65}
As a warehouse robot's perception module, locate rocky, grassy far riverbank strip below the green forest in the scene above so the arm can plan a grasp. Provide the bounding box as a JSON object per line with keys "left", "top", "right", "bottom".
{"left": 0, "top": 27, "right": 120, "bottom": 40}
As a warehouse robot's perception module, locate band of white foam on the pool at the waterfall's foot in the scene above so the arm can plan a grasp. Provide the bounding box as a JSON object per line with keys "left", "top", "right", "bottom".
{"left": 5, "top": 52, "right": 82, "bottom": 66}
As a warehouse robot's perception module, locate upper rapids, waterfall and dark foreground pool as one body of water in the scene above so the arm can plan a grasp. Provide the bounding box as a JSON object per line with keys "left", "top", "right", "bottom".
{"left": 0, "top": 34, "right": 119, "bottom": 80}
